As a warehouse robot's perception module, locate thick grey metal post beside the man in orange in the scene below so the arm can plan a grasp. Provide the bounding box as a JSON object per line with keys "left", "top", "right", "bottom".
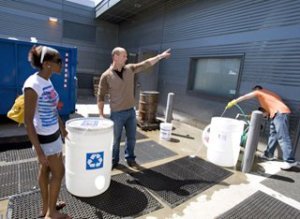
{"left": 242, "top": 110, "right": 263, "bottom": 173}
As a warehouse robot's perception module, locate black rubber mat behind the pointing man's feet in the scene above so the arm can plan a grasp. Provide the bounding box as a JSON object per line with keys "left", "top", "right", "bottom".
{"left": 120, "top": 141, "right": 176, "bottom": 164}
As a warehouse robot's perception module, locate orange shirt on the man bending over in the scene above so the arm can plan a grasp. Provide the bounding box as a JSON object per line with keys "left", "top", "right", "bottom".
{"left": 253, "top": 89, "right": 291, "bottom": 118}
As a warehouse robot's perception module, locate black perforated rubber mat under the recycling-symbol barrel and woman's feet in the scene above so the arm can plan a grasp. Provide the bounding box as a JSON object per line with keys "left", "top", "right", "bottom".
{"left": 9, "top": 173, "right": 162, "bottom": 218}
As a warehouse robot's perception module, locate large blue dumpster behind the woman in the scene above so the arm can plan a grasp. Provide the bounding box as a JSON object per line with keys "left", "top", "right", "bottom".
{"left": 0, "top": 39, "right": 77, "bottom": 118}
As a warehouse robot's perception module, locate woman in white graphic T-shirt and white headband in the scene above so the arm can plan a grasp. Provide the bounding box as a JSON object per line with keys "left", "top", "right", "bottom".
{"left": 23, "top": 46, "right": 70, "bottom": 219}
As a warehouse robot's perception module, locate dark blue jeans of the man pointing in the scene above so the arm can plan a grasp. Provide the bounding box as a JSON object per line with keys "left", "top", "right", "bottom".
{"left": 110, "top": 108, "right": 136, "bottom": 164}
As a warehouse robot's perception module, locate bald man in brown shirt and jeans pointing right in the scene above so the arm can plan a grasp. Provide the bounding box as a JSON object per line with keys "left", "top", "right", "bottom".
{"left": 97, "top": 47, "right": 171, "bottom": 168}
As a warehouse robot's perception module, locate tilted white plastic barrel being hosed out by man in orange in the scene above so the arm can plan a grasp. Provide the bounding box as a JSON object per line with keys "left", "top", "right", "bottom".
{"left": 202, "top": 117, "right": 245, "bottom": 167}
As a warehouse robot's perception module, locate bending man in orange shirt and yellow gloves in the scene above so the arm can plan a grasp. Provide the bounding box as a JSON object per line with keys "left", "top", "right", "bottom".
{"left": 226, "top": 85, "right": 297, "bottom": 170}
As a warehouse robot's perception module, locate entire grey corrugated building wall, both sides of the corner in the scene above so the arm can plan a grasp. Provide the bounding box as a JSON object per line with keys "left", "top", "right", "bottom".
{"left": 0, "top": 0, "right": 300, "bottom": 145}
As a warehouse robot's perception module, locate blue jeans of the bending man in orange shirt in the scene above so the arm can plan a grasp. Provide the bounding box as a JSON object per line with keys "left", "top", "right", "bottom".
{"left": 265, "top": 113, "right": 295, "bottom": 162}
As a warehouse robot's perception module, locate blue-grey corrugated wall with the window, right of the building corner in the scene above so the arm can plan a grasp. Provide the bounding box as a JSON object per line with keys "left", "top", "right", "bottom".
{"left": 119, "top": 0, "right": 300, "bottom": 139}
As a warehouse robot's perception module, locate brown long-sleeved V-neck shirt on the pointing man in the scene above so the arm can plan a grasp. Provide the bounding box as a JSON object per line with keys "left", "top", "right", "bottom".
{"left": 98, "top": 61, "right": 151, "bottom": 112}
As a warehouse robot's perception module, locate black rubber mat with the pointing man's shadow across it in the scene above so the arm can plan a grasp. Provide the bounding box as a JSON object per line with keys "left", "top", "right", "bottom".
{"left": 131, "top": 157, "right": 232, "bottom": 207}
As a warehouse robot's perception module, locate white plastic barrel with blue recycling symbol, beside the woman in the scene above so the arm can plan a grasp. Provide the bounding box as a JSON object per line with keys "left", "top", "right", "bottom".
{"left": 65, "top": 117, "right": 113, "bottom": 197}
